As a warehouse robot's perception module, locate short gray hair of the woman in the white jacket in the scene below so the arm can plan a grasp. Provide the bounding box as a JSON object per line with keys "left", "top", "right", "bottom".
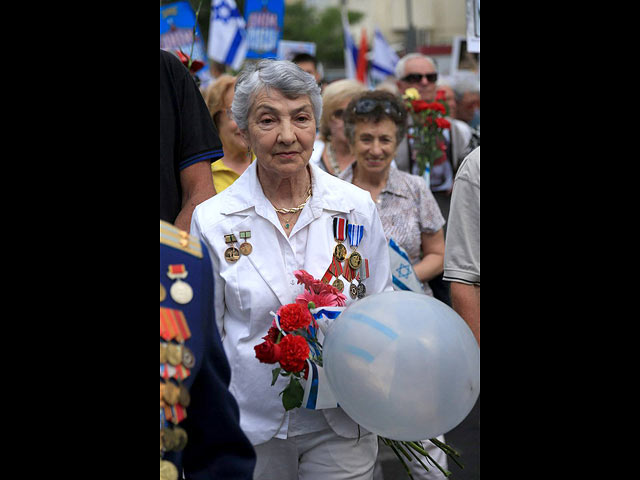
{"left": 231, "top": 59, "right": 322, "bottom": 130}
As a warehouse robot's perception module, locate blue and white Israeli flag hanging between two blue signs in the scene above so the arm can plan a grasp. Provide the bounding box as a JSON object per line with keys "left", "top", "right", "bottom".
{"left": 207, "top": 0, "right": 247, "bottom": 70}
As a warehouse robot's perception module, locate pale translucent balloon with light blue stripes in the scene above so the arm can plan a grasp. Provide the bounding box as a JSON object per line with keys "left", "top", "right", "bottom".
{"left": 323, "top": 291, "right": 480, "bottom": 441}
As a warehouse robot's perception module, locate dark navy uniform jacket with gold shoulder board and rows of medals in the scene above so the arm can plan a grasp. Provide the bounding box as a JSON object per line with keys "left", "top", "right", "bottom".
{"left": 160, "top": 220, "right": 255, "bottom": 480}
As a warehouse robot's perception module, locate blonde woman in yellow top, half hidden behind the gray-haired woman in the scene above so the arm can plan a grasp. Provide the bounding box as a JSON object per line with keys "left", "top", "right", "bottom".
{"left": 204, "top": 75, "right": 253, "bottom": 193}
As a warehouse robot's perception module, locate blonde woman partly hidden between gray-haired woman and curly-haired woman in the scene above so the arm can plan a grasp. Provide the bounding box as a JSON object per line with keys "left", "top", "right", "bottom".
{"left": 311, "top": 79, "right": 367, "bottom": 176}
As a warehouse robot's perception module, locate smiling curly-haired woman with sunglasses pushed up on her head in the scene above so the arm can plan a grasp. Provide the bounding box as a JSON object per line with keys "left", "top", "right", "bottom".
{"left": 340, "top": 90, "right": 447, "bottom": 480}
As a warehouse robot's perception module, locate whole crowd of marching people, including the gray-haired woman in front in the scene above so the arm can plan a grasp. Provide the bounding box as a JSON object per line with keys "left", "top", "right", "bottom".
{"left": 160, "top": 50, "right": 480, "bottom": 480}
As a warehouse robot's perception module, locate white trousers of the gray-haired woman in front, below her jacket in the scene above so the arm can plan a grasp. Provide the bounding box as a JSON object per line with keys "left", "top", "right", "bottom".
{"left": 253, "top": 428, "right": 378, "bottom": 480}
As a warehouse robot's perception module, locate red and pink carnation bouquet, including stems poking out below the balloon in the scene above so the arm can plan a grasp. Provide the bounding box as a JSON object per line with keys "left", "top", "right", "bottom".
{"left": 254, "top": 270, "right": 462, "bottom": 479}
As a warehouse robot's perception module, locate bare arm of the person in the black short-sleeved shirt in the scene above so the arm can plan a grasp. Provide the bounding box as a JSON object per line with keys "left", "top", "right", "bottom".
{"left": 174, "top": 161, "right": 216, "bottom": 232}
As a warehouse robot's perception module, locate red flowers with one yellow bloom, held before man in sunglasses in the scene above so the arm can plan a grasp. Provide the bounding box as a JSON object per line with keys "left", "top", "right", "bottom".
{"left": 402, "top": 88, "right": 451, "bottom": 175}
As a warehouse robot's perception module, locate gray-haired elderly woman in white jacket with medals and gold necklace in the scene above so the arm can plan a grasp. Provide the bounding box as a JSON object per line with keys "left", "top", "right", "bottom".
{"left": 191, "top": 60, "right": 392, "bottom": 480}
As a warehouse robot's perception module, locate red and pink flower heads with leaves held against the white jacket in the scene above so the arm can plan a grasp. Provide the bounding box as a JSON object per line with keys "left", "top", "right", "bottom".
{"left": 254, "top": 270, "right": 347, "bottom": 410}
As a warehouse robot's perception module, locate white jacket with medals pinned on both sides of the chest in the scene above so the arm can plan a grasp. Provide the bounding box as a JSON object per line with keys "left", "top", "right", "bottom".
{"left": 191, "top": 162, "right": 393, "bottom": 445}
